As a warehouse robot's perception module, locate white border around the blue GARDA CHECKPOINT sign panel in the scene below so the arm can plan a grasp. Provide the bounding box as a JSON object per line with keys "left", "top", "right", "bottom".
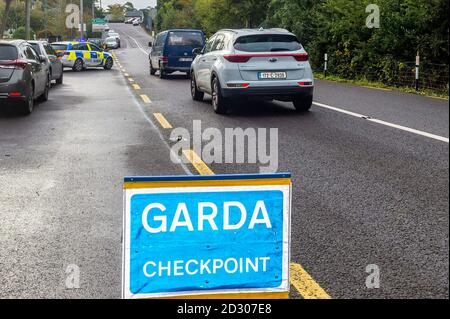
{"left": 122, "top": 185, "right": 292, "bottom": 299}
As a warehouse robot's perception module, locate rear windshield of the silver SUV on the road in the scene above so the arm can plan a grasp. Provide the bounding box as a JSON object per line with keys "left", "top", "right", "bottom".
{"left": 234, "top": 34, "right": 302, "bottom": 52}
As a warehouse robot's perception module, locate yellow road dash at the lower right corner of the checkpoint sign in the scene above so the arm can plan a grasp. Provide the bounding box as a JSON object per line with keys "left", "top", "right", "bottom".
{"left": 290, "top": 263, "right": 331, "bottom": 299}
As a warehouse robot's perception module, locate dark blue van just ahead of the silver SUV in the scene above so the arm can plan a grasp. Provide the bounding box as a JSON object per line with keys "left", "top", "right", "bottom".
{"left": 149, "top": 29, "right": 205, "bottom": 79}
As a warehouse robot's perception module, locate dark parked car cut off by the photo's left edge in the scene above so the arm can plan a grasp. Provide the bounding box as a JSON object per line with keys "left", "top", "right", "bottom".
{"left": 0, "top": 40, "right": 50, "bottom": 114}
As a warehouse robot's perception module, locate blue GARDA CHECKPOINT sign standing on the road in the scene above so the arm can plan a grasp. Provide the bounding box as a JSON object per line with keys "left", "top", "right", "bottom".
{"left": 122, "top": 173, "right": 292, "bottom": 299}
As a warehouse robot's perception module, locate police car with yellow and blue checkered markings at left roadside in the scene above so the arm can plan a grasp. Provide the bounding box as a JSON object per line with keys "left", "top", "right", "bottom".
{"left": 51, "top": 42, "right": 114, "bottom": 72}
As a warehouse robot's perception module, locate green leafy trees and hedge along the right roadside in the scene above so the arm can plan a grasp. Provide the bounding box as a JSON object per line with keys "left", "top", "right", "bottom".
{"left": 157, "top": 0, "right": 449, "bottom": 87}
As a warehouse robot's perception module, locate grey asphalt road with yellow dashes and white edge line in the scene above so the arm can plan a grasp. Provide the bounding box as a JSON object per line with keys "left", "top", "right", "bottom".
{"left": 0, "top": 24, "right": 449, "bottom": 298}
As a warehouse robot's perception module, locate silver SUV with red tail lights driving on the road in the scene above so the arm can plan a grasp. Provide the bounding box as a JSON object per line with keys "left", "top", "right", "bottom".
{"left": 191, "top": 29, "right": 314, "bottom": 114}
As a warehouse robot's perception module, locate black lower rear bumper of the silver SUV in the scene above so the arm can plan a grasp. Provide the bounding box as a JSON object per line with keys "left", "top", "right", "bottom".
{"left": 222, "top": 86, "right": 314, "bottom": 100}
